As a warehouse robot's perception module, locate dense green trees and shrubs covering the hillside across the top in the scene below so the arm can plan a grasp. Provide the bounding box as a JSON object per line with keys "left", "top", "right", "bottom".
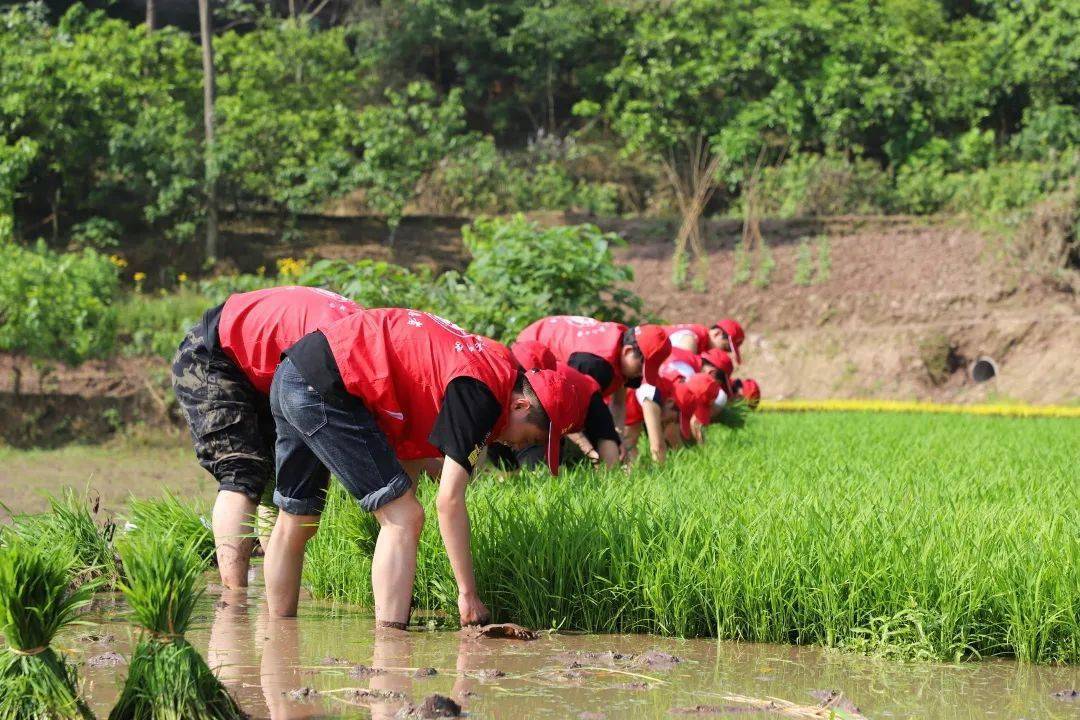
{"left": 0, "top": 0, "right": 1080, "bottom": 259}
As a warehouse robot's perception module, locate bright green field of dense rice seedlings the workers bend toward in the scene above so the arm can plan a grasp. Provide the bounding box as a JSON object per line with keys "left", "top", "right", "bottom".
{"left": 306, "top": 412, "right": 1080, "bottom": 663}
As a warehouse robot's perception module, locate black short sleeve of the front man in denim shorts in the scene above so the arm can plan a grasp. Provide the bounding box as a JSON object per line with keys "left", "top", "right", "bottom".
{"left": 428, "top": 378, "right": 502, "bottom": 473}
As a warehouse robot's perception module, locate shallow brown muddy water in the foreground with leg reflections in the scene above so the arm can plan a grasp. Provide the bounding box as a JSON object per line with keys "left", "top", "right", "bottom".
{"left": 67, "top": 589, "right": 1080, "bottom": 720}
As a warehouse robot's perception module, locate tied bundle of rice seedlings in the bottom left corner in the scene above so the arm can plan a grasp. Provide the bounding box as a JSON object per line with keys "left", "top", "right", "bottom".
{"left": 0, "top": 535, "right": 94, "bottom": 720}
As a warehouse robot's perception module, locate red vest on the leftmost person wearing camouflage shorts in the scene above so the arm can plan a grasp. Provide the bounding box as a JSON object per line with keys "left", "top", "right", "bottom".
{"left": 217, "top": 286, "right": 360, "bottom": 395}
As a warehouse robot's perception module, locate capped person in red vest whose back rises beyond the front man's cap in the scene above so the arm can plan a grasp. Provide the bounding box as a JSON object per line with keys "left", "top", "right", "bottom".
{"left": 517, "top": 315, "right": 671, "bottom": 430}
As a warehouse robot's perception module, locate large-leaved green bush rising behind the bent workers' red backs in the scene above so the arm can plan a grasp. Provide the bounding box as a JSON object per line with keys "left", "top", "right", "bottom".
{"left": 441, "top": 215, "right": 642, "bottom": 340}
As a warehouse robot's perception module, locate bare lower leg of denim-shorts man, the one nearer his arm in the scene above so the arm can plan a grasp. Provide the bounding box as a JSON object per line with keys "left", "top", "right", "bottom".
{"left": 369, "top": 489, "right": 423, "bottom": 623}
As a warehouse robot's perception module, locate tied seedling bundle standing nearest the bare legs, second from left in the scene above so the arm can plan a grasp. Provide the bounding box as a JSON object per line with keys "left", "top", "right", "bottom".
{"left": 109, "top": 533, "right": 246, "bottom": 720}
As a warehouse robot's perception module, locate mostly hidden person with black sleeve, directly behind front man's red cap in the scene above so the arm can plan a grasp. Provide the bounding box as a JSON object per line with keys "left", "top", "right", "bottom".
{"left": 492, "top": 341, "right": 622, "bottom": 468}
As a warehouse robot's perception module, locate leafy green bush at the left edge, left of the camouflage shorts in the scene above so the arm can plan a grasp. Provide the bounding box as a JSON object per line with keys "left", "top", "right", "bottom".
{"left": 0, "top": 242, "right": 118, "bottom": 377}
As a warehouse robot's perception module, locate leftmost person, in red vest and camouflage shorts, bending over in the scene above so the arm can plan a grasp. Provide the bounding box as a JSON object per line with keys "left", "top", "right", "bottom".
{"left": 172, "top": 287, "right": 360, "bottom": 587}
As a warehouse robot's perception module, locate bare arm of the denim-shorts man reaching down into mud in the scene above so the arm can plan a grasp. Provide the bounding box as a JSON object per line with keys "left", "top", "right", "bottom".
{"left": 435, "top": 457, "right": 490, "bottom": 625}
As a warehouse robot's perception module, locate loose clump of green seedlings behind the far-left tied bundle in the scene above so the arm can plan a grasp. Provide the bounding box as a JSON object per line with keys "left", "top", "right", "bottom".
{"left": 6, "top": 490, "right": 120, "bottom": 584}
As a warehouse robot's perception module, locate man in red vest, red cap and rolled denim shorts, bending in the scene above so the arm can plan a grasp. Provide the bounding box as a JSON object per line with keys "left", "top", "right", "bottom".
{"left": 265, "top": 309, "right": 586, "bottom": 628}
